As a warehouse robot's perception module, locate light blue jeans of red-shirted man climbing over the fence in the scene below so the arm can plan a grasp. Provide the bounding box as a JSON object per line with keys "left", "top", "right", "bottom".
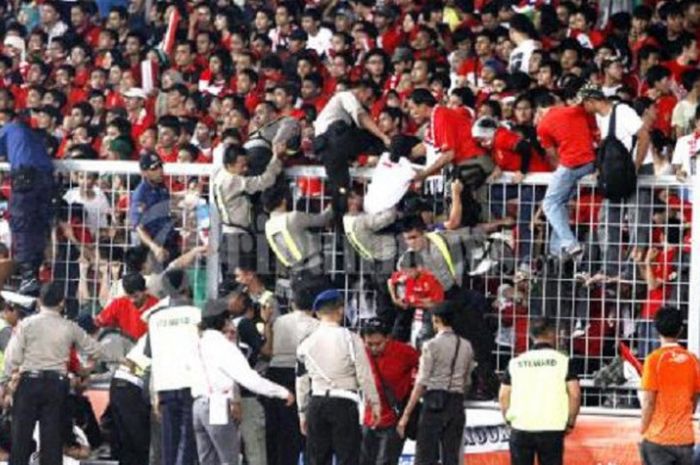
{"left": 542, "top": 163, "right": 595, "bottom": 255}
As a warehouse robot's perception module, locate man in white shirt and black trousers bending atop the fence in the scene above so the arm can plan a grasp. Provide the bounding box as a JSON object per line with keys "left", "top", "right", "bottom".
{"left": 313, "top": 80, "right": 391, "bottom": 215}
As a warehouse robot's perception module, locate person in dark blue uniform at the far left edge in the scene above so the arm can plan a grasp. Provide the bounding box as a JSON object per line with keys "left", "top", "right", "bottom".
{"left": 0, "top": 112, "right": 54, "bottom": 296}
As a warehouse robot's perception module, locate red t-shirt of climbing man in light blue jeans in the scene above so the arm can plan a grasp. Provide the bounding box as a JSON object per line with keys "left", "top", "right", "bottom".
{"left": 537, "top": 105, "right": 595, "bottom": 168}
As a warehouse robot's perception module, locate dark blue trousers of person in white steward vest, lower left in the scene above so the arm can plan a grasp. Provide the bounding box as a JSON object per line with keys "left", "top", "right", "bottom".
{"left": 158, "top": 389, "right": 197, "bottom": 465}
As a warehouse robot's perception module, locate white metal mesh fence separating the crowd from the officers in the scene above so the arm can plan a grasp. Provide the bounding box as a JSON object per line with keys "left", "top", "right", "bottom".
{"left": 0, "top": 161, "right": 700, "bottom": 408}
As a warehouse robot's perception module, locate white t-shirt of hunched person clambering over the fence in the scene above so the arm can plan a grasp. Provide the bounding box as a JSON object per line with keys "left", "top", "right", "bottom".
{"left": 363, "top": 153, "right": 416, "bottom": 214}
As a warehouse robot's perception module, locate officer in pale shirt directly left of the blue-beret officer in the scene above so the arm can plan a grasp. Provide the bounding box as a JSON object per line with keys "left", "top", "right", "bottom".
{"left": 262, "top": 285, "right": 319, "bottom": 465}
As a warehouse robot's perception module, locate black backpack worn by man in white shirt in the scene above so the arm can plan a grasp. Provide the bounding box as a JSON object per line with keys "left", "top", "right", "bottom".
{"left": 598, "top": 105, "right": 637, "bottom": 202}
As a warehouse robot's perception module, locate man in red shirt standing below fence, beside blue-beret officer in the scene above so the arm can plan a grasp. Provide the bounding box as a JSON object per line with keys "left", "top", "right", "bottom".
{"left": 360, "top": 318, "right": 419, "bottom": 465}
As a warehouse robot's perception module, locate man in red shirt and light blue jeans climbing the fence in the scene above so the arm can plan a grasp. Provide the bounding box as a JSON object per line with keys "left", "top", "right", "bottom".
{"left": 536, "top": 90, "right": 595, "bottom": 257}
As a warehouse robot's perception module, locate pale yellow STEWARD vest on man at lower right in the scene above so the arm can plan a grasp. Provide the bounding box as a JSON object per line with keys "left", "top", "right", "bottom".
{"left": 506, "top": 349, "right": 569, "bottom": 431}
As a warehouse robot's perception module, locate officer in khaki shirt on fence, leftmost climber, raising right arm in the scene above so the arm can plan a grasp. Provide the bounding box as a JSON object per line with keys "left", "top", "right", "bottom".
{"left": 213, "top": 141, "right": 284, "bottom": 274}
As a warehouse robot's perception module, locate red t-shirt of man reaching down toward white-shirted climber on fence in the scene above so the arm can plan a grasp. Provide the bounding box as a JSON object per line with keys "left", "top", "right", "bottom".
{"left": 426, "top": 106, "right": 484, "bottom": 165}
